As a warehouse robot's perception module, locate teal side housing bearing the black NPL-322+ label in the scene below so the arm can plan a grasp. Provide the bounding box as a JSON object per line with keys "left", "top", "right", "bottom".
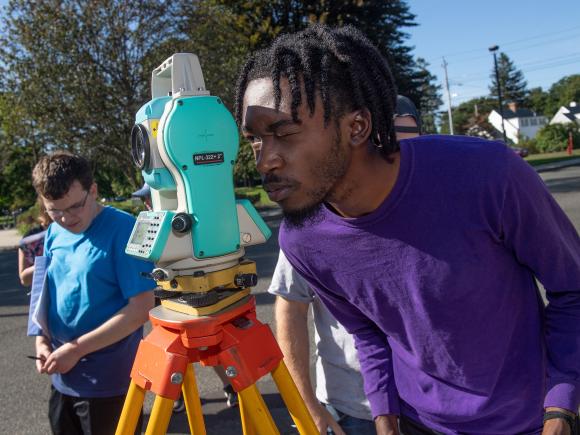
{"left": 163, "top": 96, "right": 240, "bottom": 258}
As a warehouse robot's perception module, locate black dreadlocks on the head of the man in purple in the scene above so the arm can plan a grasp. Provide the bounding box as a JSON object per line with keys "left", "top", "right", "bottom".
{"left": 235, "top": 24, "right": 398, "bottom": 157}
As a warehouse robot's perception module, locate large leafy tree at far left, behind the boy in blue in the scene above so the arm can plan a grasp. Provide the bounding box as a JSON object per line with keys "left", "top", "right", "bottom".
{"left": 0, "top": 0, "right": 177, "bottom": 201}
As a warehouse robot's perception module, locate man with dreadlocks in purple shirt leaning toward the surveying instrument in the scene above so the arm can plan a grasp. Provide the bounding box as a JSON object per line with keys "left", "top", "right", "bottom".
{"left": 236, "top": 26, "right": 580, "bottom": 434}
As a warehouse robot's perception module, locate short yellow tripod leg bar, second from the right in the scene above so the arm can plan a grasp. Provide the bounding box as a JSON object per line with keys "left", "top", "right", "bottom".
{"left": 238, "top": 384, "right": 280, "bottom": 435}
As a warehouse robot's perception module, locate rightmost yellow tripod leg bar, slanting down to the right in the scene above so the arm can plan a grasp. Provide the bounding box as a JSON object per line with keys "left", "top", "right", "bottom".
{"left": 272, "top": 361, "right": 319, "bottom": 435}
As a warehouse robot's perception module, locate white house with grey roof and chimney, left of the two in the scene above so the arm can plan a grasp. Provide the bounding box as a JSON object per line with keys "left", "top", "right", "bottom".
{"left": 487, "top": 103, "right": 548, "bottom": 144}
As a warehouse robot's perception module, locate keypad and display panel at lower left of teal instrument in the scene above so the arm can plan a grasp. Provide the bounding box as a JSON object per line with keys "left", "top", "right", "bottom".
{"left": 125, "top": 211, "right": 175, "bottom": 262}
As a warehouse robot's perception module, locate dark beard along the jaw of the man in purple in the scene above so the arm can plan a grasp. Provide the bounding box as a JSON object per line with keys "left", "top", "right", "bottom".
{"left": 282, "top": 126, "right": 348, "bottom": 229}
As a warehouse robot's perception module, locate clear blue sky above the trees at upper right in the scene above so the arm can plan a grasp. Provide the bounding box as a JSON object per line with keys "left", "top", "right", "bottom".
{"left": 407, "top": 0, "right": 580, "bottom": 107}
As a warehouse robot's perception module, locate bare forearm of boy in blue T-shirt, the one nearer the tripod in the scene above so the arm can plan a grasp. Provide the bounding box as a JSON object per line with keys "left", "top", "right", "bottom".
{"left": 71, "top": 292, "right": 154, "bottom": 357}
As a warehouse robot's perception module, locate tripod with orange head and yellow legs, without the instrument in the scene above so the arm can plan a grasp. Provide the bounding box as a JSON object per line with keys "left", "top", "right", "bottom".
{"left": 116, "top": 296, "right": 318, "bottom": 435}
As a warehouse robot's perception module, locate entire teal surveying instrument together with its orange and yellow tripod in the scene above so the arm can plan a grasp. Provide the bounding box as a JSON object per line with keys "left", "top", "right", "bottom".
{"left": 116, "top": 53, "right": 318, "bottom": 435}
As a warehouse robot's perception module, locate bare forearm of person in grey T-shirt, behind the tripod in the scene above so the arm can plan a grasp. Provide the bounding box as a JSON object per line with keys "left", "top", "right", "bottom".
{"left": 275, "top": 297, "right": 319, "bottom": 410}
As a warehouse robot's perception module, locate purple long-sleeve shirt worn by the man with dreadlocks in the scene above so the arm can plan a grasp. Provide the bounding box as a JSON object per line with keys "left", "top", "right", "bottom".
{"left": 280, "top": 136, "right": 580, "bottom": 435}
